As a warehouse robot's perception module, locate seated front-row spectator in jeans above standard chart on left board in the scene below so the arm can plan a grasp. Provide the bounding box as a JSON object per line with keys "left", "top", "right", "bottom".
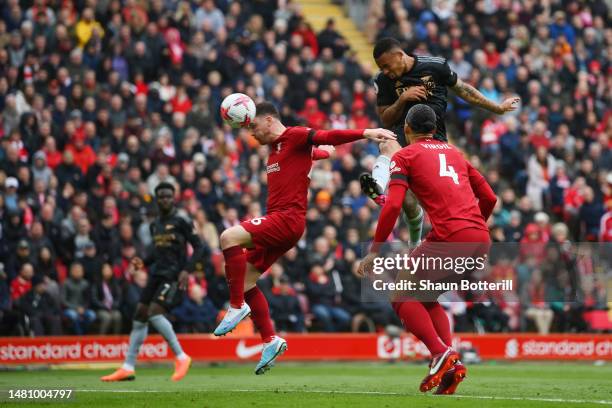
{"left": 62, "top": 262, "right": 96, "bottom": 335}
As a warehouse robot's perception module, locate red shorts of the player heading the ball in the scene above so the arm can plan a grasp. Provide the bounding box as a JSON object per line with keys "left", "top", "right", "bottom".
{"left": 240, "top": 212, "right": 306, "bottom": 273}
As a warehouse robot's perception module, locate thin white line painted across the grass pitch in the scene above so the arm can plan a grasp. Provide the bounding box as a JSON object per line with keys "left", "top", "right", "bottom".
{"left": 74, "top": 389, "right": 612, "bottom": 405}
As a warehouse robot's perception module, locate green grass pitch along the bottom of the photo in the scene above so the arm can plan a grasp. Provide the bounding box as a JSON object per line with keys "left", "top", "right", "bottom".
{"left": 0, "top": 360, "right": 612, "bottom": 408}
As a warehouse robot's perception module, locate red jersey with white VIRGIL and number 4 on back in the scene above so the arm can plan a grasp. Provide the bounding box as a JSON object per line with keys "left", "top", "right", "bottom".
{"left": 389, "top": 138, "right": 488, "bottom": 240}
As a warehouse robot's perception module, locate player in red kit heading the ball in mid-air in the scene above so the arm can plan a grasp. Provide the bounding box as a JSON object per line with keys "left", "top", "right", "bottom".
{"left": 214, "top": 102, "right": 395, "bottom": 375}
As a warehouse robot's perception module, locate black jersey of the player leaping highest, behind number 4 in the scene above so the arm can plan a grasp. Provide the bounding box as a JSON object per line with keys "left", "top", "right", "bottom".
{"left": 374, "top": 55, "right": 457, "bottom": 146}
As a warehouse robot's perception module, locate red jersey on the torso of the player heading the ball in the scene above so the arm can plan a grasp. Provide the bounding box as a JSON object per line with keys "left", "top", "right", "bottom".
{"left": 266, "top": 127, "right": 312, "bottom": 214}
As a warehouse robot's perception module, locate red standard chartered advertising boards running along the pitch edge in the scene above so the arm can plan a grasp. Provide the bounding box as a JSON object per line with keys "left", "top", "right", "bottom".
{"left": 0, "top": 334, "right": 612, "bottom": 364}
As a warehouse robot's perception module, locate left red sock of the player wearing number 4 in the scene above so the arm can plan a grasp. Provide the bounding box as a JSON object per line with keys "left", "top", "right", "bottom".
{"left": 393, "top": 301, "right": 448, "bottom": 356}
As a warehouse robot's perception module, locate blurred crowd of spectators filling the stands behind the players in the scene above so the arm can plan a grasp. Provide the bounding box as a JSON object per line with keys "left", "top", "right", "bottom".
{"left": 0, "top": 0, "right": 612, "bottom": 336}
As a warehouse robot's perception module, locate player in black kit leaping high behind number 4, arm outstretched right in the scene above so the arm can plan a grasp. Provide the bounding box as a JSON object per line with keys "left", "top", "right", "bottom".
{"left": 360, "top": 38, "right": 520, "bottom": 249}
